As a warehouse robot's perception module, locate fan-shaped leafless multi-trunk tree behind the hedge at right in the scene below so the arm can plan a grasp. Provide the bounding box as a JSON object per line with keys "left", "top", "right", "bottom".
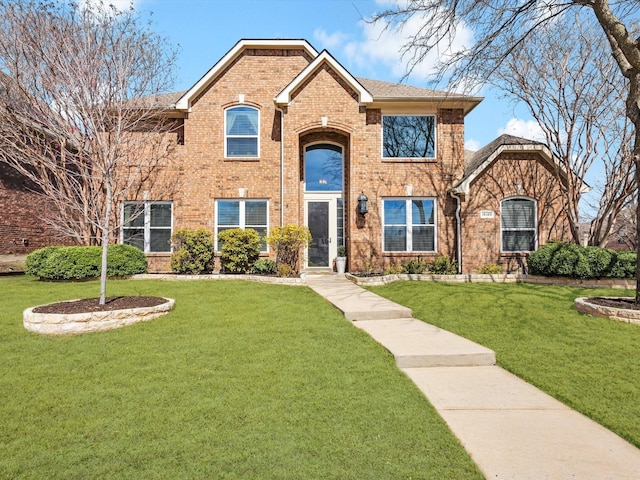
{"left": 489, "top": 16, "right": 636, "bottom": 246}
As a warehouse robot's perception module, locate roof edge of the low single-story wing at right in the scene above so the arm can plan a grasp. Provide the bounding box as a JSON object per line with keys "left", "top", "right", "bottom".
{"left": 453, "top": 134, "right": 591, "bottom": 195}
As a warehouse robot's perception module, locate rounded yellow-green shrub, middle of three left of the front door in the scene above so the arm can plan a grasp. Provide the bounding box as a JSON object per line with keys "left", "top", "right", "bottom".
{"left": 218, "top": 228, "right": 262, "bottom": 273}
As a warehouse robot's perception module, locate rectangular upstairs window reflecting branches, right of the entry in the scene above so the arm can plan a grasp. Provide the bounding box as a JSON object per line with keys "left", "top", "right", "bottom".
{"left": 382, "top": 115, "right": 436, "bottom": 158}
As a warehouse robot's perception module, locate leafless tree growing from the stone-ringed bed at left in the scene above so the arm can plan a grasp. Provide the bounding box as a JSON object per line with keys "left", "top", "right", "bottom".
{"left": 0, "top": 0, "right": 175, "bottom": 303}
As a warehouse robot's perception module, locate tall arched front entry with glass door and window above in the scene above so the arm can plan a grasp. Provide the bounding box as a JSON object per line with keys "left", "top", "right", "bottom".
{"left": 304, "top": 143, "right": 344, "bottom": 270}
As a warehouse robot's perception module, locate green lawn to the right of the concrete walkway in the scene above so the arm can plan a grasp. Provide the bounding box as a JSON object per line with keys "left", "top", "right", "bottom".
{"left": 371, "top": 282, "right": 640, "bottom": 447}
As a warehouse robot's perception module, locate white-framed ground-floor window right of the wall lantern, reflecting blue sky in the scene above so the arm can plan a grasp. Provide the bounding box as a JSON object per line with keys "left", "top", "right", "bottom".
{"left": 382, "top": 198, "right": 436, "bottom": 252}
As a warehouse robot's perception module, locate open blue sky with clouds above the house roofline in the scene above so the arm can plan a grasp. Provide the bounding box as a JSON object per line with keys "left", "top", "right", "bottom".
{"left": 114, "top": 0, "right": 541, "bottom": 150}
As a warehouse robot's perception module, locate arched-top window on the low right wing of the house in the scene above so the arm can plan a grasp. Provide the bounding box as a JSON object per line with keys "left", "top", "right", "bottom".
{"left": 500, "top": 198, "right": 538, "bottom": 253}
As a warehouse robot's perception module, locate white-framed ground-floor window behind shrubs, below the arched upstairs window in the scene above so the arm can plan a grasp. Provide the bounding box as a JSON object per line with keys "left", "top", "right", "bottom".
{"left": 215, "top": 200, "right": 269, "bottom": 253}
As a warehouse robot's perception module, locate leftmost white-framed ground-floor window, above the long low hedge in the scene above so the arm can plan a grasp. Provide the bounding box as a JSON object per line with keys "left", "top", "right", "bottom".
{"left": 122, "top": 202, "right": 173, "bottom": 253}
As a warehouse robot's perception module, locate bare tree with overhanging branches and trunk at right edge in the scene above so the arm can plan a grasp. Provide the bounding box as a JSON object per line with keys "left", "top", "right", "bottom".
{"left": 371, "top": 0, "right": 640, "bottom": 303}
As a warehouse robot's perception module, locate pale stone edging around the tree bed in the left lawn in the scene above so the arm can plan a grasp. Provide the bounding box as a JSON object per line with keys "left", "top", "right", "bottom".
{"left": 22, "top": 297, "right": 175, "bottom": 335}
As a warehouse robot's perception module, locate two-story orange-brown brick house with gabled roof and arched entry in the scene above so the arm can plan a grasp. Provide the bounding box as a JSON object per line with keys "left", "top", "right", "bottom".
{"left": 121, "top": 40, "right": 567, "bottom": 272}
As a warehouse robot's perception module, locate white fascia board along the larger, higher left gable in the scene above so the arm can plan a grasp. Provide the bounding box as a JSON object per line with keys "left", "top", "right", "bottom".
{"left": 176, "top": 40, "right": 318, "bottom": 111}
